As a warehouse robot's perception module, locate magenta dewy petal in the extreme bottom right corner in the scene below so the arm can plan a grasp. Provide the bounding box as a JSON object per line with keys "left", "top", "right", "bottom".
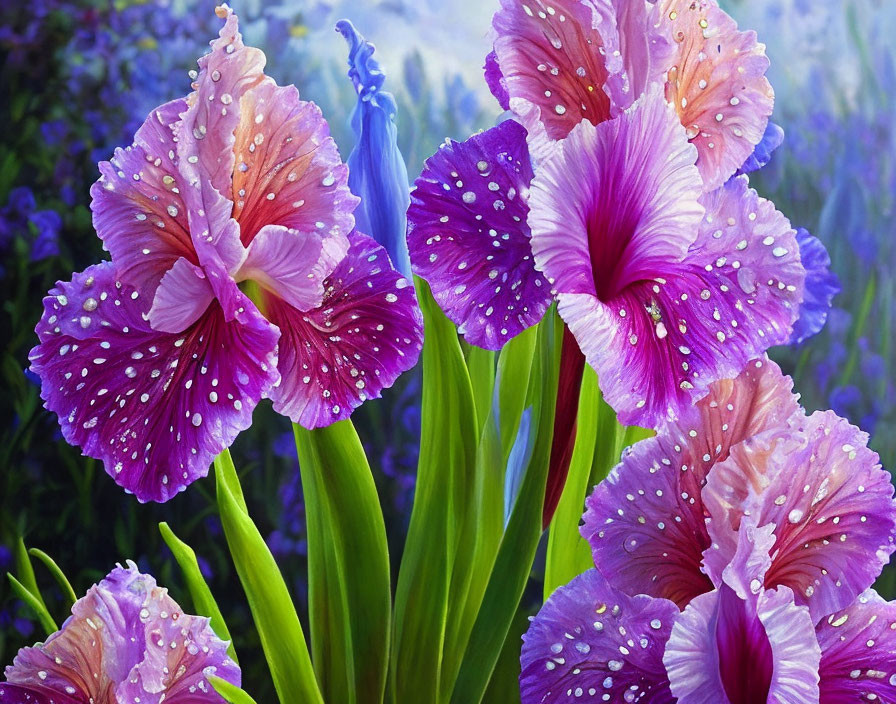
{"left": 816, "top": 589, "right": 896, "bottom": 704}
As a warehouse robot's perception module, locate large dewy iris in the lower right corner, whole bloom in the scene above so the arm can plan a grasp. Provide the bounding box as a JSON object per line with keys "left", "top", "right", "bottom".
{"left": 520, "top": 359, "right": 896, "bottom": 704}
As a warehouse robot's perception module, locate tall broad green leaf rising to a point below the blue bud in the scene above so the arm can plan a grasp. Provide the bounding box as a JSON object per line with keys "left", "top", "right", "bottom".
{"left": 390, "top": 279, "right": 479, "bottom": 704}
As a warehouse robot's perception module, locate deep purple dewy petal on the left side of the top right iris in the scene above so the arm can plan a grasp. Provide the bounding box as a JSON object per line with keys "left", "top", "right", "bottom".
{"left": 408, "top": 120, "right": 551, "bottom": 350}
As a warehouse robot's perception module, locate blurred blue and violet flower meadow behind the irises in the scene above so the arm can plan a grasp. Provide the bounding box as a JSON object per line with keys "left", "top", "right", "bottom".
{"left": 0, "top": 0, "right": 896, "bottom": 701}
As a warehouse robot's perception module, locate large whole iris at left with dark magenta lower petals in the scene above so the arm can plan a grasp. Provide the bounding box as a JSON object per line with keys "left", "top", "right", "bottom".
{"left": 30, "top": 5, "right": 422, "bottom": 501}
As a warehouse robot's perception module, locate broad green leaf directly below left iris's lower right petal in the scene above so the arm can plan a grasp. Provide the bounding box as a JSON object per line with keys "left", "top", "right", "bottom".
{"left": 293, "top": 420, "right": 392, "bottom": 704}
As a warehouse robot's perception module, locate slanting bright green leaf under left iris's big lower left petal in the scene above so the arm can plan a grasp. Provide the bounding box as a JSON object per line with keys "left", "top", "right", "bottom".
{"left": 215, "top": 450, "right": 323, "bottom": 704}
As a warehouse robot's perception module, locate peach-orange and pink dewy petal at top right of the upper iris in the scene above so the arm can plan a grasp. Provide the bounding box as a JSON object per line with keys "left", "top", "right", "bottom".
{"left": 654, "top": 0, "right": 774, "bottom": 191}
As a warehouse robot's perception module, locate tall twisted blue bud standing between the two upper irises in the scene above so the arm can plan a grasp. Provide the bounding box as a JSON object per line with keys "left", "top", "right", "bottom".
{"left": 336, "top": 20, "right": 411, "bottom": 277}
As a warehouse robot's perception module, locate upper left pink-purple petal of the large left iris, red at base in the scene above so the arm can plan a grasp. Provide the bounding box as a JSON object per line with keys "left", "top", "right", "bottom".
{"left": 90, "top": 99, "right": 198, "bottom": 296}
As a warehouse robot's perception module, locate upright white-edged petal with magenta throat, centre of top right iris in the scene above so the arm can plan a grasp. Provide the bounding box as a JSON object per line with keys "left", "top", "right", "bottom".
{"left": 529, "top": 85, "right": 704, "bottom": 302}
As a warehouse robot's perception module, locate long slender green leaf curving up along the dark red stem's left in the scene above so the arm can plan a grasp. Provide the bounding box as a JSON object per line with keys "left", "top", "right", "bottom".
{"left": 451, "top": 306, "right": 563, "bottom": 704}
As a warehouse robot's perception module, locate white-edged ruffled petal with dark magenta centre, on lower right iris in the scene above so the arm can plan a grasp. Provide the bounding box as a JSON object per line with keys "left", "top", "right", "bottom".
{"left": 663, "top": 526, "right": 820, "bottom": 704}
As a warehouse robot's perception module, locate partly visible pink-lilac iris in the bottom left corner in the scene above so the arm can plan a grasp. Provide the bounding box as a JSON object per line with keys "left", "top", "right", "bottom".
{"left": 0, "top": 563, "right": 240, "bottom": 704}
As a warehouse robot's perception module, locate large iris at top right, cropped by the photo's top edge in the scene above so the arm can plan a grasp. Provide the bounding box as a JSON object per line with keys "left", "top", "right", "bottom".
{"left": 408, "top": 0, "right": 826, "bottom": 427}
